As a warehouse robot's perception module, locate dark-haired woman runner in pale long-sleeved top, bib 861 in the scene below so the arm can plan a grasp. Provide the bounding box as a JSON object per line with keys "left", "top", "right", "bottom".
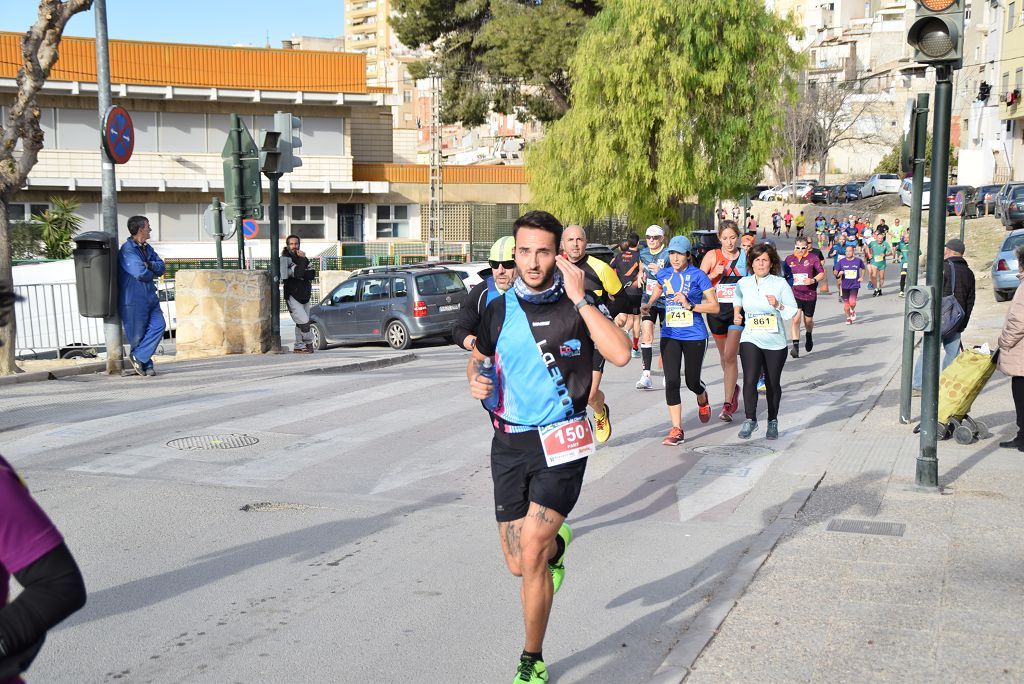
{"left": 732, "top": 245, "right": 799, "bottom": 439}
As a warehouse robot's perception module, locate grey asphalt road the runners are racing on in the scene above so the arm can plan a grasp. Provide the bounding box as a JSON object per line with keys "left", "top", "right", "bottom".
{"left": 0, "top": 245, "right": 902, "bottom": 682}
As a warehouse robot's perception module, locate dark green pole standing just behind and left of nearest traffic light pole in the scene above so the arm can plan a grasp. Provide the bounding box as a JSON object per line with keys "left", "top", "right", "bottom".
{"left": 899, "top": 92, "right": 929, "bottom": 425}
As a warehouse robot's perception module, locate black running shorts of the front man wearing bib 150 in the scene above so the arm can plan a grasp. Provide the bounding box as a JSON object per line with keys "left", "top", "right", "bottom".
{"left": 490, "top": 430, "right": 587, "bottom": 522}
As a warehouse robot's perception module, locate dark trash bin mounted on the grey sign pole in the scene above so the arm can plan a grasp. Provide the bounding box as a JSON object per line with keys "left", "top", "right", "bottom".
{"left": 72, "top": 230, "right": 118, "bottom": 318}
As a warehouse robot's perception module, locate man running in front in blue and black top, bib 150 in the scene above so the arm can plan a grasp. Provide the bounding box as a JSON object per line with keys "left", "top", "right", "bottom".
{"left": 466, "top": 211, "right": 630, "bottom": 683}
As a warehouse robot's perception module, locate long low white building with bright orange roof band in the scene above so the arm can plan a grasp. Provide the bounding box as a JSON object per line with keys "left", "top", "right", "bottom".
{"left": 0, "top": 33, "right": 526, "bottom": 257}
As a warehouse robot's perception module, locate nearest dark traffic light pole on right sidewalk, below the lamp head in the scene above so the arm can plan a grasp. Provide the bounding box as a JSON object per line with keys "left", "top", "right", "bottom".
{"left": 914, "top": 65, "right": 953, "bottom": 488}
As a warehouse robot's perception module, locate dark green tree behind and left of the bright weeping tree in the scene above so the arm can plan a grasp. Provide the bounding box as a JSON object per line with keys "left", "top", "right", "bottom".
{"left": 390, "top": 0, "right": 602, "bottom": 126}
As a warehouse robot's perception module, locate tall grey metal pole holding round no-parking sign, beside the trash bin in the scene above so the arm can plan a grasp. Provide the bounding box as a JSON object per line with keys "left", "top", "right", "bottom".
{"left": 92, "top": 0, "right": 124, "bottom": 375}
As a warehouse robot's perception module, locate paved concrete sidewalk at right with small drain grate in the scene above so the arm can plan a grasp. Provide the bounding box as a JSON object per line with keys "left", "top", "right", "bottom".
{"left": 687, "top": 358, "right": 1024, "bottom": 682}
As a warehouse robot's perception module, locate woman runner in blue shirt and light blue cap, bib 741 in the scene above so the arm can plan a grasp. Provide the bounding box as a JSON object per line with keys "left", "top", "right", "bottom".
{"left": 640, "top": 236, "right": 719, "bottom": 446}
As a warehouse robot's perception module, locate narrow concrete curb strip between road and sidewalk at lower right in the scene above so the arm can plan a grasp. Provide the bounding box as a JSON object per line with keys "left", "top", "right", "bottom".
{"left": 648, "top": 472, "right": 825, "bottom": 684}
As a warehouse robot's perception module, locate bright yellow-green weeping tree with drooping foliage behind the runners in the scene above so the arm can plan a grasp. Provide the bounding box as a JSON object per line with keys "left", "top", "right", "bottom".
{"left": 527, "top": 0, "right": 802, "bottom": 225}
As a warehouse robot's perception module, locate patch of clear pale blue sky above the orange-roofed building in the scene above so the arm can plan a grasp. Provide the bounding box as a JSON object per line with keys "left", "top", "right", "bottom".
{"left": 0, "top": 0, "right": 345, "bottom": 47}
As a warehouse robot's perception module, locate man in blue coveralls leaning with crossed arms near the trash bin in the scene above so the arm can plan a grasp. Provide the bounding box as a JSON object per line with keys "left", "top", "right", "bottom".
{"left": 118, "top": 216, "right": 165, "bottom": 376}
